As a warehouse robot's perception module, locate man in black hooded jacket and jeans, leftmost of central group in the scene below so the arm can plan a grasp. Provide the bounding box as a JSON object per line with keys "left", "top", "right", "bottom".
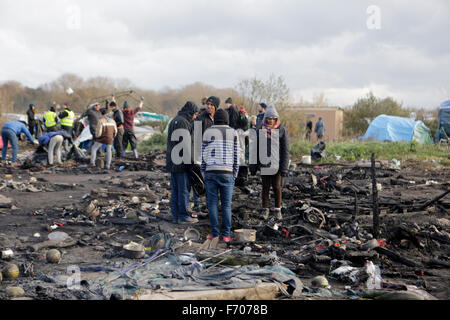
{"left": 166, "top": 101, "right": 198, "bottom": 224}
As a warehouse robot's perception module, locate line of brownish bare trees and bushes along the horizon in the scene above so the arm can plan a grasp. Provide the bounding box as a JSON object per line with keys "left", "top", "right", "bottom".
{"left": 0, "top": 73, "right": 438, "bottom": 137}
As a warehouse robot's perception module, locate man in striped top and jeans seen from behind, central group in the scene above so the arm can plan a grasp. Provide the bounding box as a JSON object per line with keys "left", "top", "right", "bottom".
{"left": 201, "top": 109, "right": 240, "bottom": 242}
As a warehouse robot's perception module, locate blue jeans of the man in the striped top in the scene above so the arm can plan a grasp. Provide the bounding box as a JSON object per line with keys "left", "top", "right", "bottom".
{"left": 205, "top": 173, "right": 234, "bottom": 237}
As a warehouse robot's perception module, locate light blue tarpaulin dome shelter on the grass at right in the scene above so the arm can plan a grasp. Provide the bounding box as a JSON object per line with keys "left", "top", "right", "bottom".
{"left": 360, "top": 114, "right": 433, "bottom": 144}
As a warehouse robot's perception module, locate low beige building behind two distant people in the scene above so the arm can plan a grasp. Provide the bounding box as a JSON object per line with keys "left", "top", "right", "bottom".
{"left": 286, "top": 106, "right": 344, "bottom": 141}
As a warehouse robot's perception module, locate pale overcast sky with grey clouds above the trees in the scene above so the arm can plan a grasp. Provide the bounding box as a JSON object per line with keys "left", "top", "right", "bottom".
{"left": 0, "top": 0, "right": 450, "bottom": 107}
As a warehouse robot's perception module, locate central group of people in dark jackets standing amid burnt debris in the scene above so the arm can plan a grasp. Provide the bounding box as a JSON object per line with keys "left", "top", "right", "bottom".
{"left": 166, "top": 96, "right": 289, "bottom": 242}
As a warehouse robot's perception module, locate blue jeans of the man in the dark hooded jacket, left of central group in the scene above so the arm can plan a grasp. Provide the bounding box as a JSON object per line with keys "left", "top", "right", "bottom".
{"left": 170, "top": 172, "right": 191, "bottom": 222}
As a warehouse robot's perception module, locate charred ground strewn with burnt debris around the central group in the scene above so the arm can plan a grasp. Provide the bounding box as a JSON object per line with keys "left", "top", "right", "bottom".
{"left": 0, "top": 153, "right": 450, "bottom": 300}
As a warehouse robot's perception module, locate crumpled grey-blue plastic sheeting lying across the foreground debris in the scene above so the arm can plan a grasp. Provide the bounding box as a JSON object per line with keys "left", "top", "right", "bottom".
{"left": 90, "top": 254, "right": 303, "bottom": 299}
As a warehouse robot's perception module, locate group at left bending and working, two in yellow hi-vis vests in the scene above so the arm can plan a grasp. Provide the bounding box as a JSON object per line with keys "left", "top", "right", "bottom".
{"left": 1, "top": 95, "right": 144, "bottom": 169}
